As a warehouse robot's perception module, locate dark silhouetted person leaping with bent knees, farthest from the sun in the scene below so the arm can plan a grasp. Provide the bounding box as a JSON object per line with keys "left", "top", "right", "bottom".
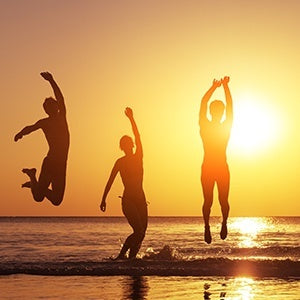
{"left": 14, "top": 72, "right": 70, "bottom": 206}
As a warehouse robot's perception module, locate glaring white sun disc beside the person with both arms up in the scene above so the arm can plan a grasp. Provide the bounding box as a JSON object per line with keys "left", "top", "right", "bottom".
{"left": 230, "top": 96, "right": 278, "bottom": 154}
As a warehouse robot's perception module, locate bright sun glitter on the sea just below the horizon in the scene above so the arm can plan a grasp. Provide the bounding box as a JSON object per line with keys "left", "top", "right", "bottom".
{"left": 230, "top": 218, "right": 270, "bottom": 248}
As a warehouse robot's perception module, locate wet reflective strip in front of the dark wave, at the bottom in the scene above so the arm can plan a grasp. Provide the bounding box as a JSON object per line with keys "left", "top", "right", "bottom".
{"left": 0, "top": 275, "right": 300, "bottom": 300}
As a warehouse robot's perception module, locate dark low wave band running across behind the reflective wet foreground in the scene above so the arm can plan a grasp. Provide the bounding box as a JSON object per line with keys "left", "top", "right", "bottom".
{"left": 0, "top": 258, "right": 300, "bottom": 278}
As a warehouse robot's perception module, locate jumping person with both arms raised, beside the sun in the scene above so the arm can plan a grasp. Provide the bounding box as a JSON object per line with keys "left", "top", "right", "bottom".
{"left": 199, "top": 76, "right": 233, "bottom": 244}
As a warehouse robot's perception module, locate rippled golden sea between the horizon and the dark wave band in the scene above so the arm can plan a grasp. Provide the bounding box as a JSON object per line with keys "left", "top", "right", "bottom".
{"left": 0, "top": 217, "right": 300, "bottom": 262}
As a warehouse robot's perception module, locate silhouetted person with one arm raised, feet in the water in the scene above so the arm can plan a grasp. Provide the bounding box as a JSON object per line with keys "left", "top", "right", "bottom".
{"left": 100, "top": 107, "right": 148, "bottom": 259}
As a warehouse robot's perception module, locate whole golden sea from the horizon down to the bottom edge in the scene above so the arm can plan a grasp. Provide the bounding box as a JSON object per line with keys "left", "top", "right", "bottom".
{"left": 0, "top": 217, "right": 300, "bottom": 300}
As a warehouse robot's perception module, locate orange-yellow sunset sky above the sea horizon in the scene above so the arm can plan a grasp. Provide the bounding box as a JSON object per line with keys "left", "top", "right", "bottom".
{"left": 0, "top": 0, "right": 300, "bottom": 216}
